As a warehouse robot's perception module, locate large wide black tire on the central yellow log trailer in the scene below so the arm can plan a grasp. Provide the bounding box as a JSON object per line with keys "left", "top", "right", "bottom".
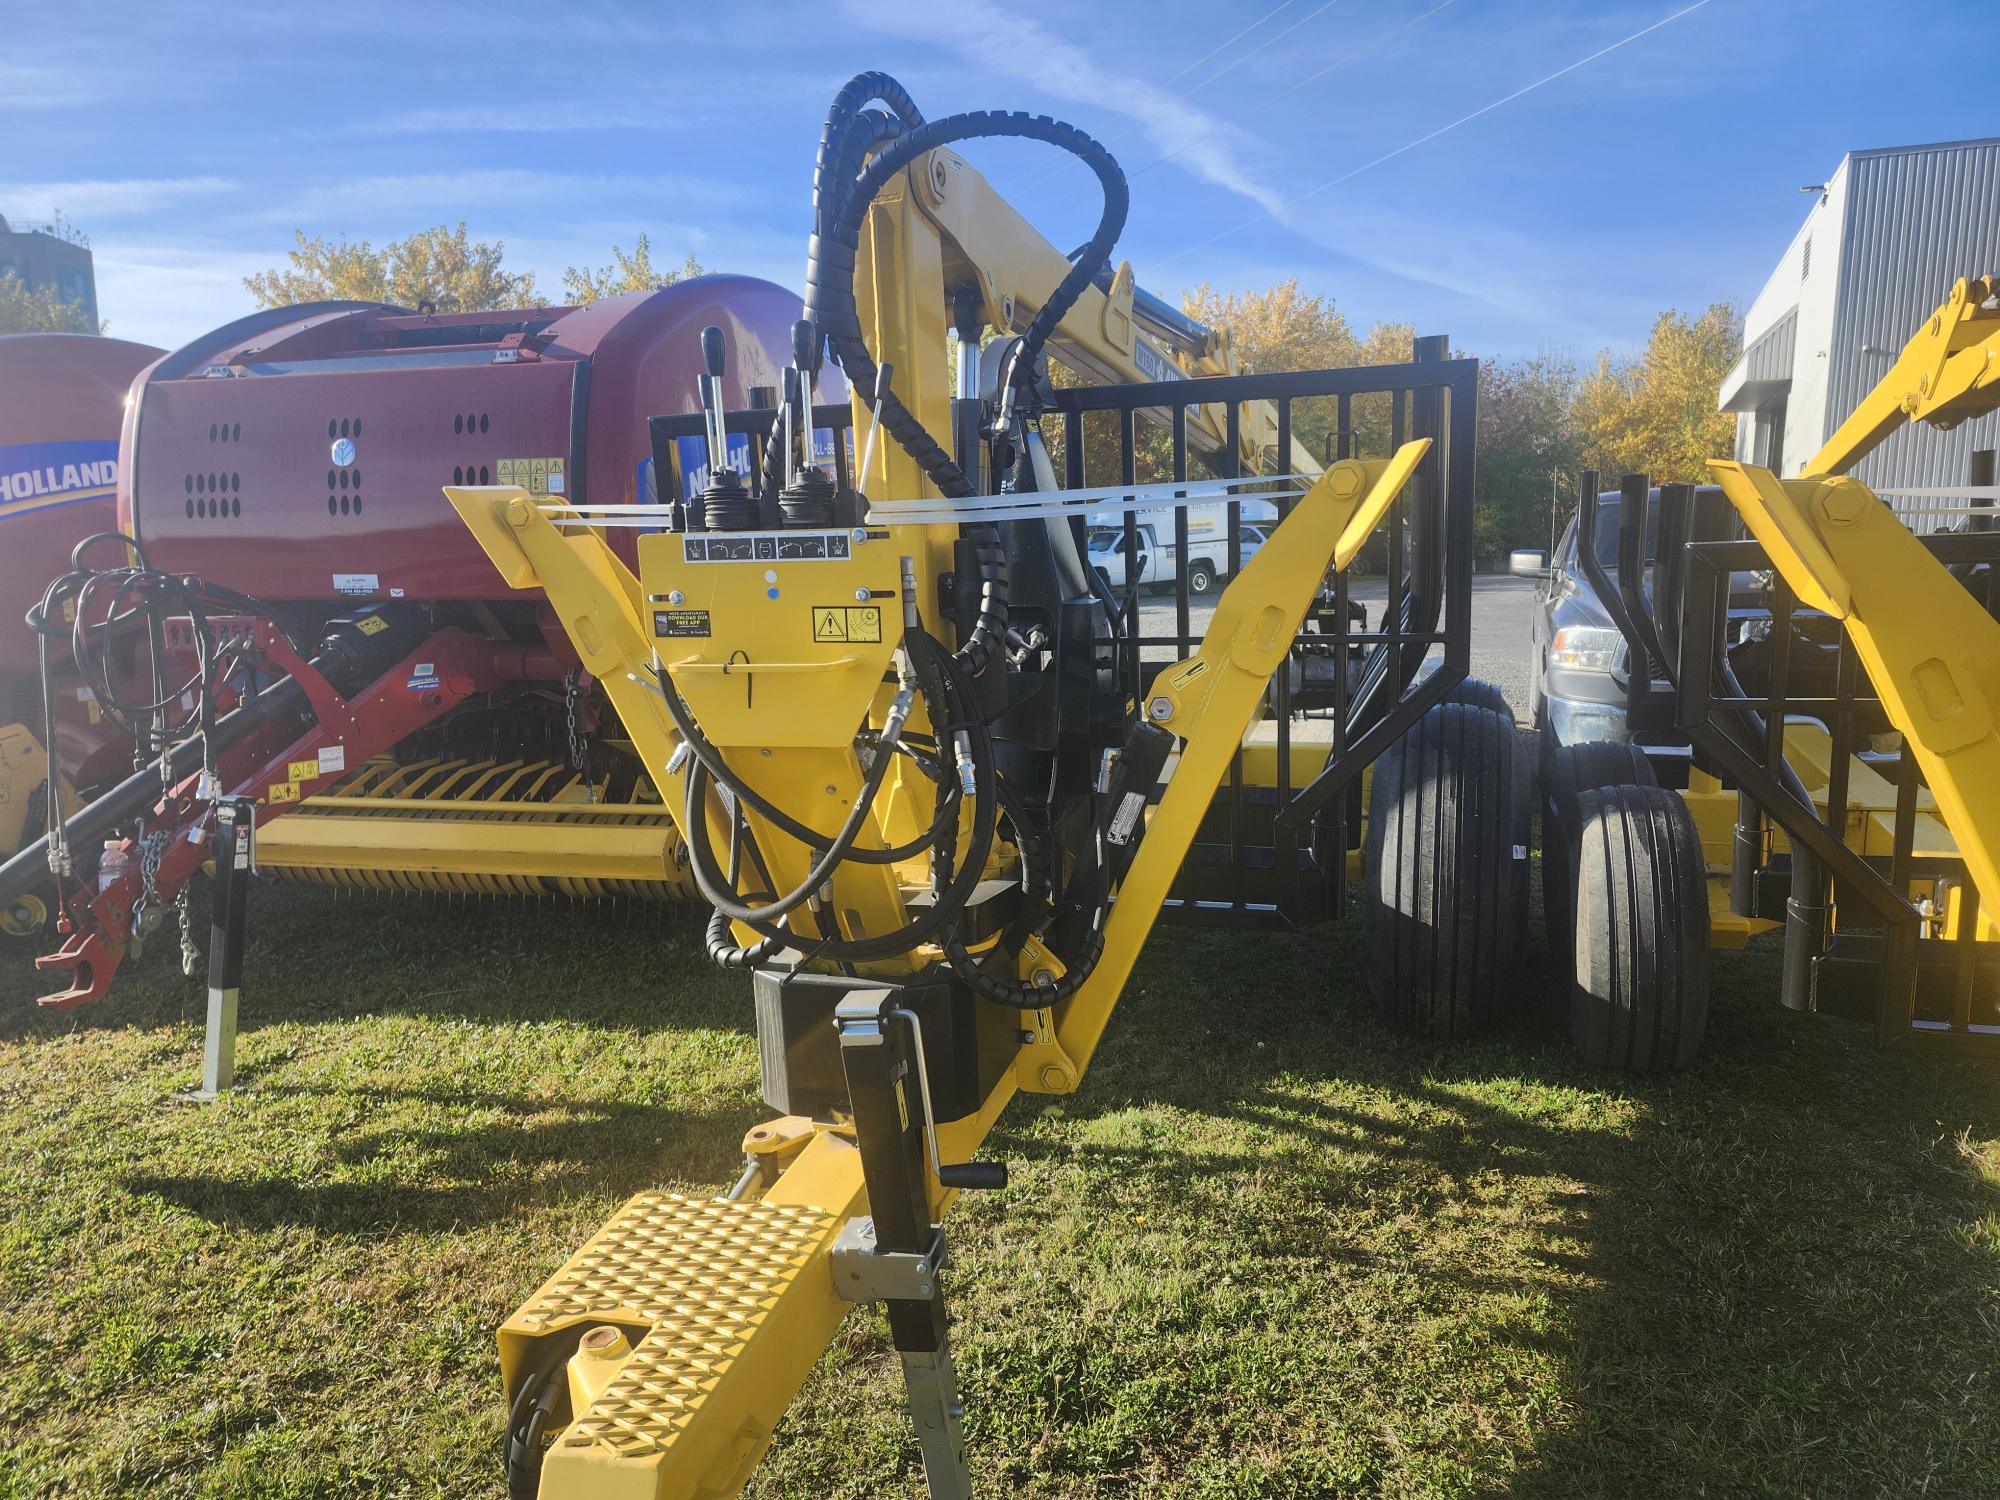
{"left": 1364, "top": 704, "right": 1528, "bottom": 1042}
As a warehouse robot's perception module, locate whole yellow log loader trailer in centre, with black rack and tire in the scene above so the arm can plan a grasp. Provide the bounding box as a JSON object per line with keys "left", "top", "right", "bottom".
{"left": 446, "top": 76, "right": 1504, "bottom": 1496}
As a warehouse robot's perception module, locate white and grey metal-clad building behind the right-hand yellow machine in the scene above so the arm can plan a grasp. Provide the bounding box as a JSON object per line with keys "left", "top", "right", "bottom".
{"left": 1720, "top": 138, "right": 2000, "bottom": 512}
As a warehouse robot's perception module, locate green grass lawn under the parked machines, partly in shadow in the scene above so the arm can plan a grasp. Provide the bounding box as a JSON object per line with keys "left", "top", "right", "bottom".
{"left": 0, "top": 888, "right": 2000, "bottom": 1500}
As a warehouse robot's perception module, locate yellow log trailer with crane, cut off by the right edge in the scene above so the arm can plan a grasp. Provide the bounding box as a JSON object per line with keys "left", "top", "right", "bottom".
{"left": 1542, "top": 278, "right": 2000, "bottom": 1068}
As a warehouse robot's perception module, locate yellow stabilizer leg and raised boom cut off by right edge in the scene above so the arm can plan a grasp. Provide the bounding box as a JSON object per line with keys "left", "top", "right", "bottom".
{"left": 1710, "top": 278, "right": 2000, "bottom": 924}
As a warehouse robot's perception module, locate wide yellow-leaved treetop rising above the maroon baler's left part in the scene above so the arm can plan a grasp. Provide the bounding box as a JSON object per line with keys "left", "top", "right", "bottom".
{"left": 244, "top": 220, "right": 536, "bottom": 312}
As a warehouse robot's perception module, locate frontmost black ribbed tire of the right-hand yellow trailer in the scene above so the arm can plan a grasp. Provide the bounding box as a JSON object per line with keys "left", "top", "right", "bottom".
{"left": 1570, "top": 786, "right": 1708, "bottom": 1072}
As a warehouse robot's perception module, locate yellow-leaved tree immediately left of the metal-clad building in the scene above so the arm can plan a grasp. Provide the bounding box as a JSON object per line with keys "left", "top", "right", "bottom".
{"left": 1570, "top": 302, "right": 1742, "bottom": 482}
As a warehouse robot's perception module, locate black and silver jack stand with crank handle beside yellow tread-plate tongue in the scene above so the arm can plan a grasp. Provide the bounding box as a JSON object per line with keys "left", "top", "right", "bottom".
{"left": 832, "top": 988, "right": 1006, "bottom": 1500}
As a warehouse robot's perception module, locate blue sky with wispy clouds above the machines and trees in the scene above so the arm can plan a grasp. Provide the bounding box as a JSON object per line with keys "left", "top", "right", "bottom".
{"left": 0, "top": 0, "right": 2000, "bottom": 356}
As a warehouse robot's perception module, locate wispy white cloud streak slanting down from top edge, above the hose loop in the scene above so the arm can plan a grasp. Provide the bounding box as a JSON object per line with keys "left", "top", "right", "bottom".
{"left": 844, "top": 0, "right": 1284, "bottom": 214}
